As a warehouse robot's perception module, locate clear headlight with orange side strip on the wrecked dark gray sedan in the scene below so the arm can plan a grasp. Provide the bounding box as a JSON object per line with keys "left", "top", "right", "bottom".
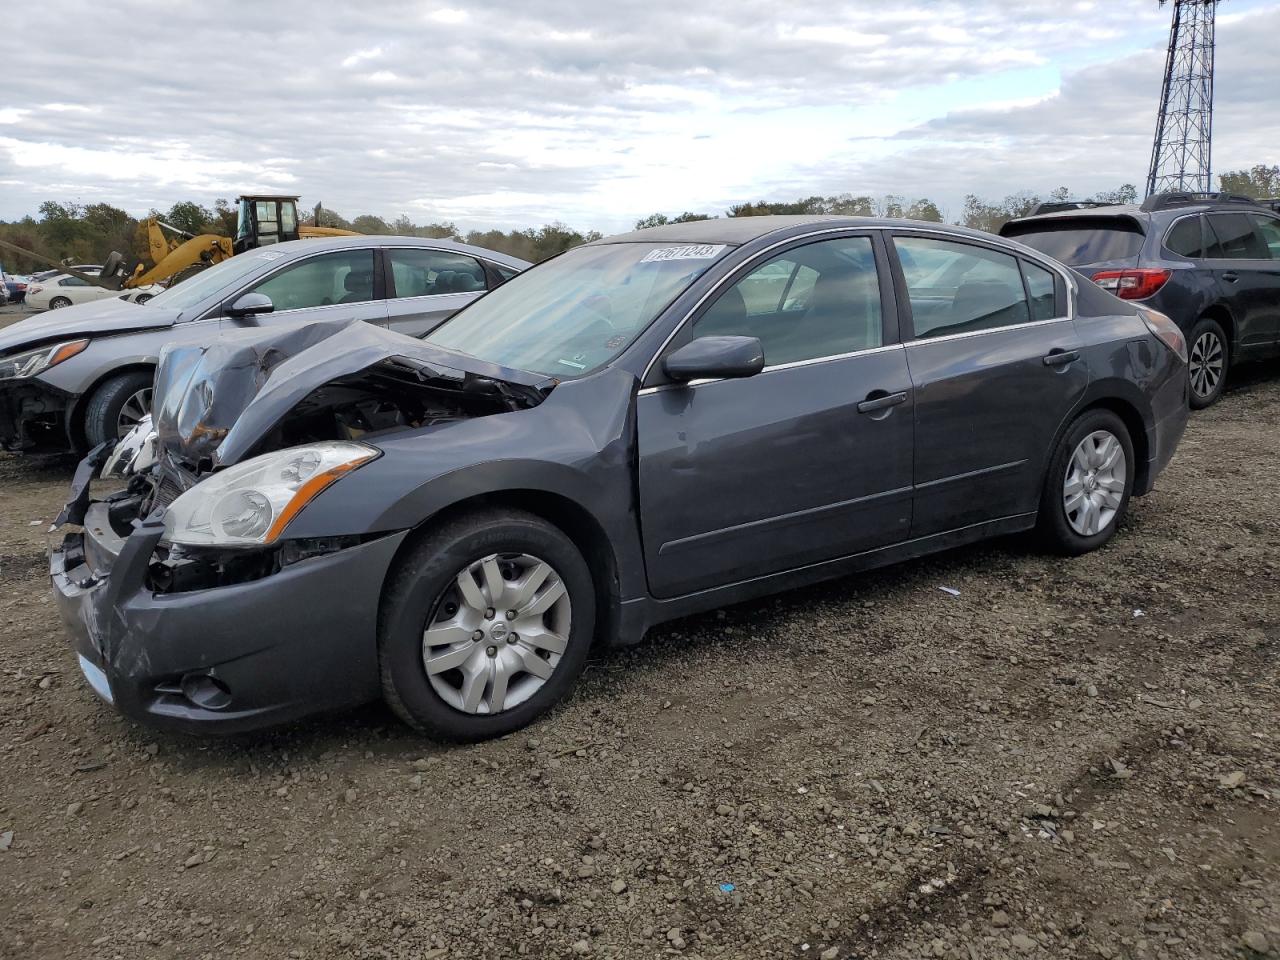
{"left": 164, "top": 440, "right": 379, "bottom": 547}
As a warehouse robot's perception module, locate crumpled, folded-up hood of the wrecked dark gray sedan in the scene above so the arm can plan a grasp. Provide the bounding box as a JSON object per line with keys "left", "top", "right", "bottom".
{"left": 152, "top": 320, "right": 556, "bottom": 467}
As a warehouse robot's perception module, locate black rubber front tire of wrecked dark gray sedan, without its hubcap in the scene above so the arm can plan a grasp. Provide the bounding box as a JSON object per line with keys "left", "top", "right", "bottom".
{"left": 378, "top": 509, "right": 595, "bottom": 742}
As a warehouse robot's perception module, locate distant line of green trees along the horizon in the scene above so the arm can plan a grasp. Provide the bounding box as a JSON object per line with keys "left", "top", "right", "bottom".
{"left": 0, "top": 164, "right": 1280, "bottom": 273}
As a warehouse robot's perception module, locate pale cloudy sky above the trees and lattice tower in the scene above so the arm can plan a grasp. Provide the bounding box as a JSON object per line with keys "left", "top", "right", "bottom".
{"left": 0, "top": 0, "right": 1280, "bottom": 232}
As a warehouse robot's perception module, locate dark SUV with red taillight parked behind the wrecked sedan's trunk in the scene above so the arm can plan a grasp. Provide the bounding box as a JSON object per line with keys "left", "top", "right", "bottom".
{"left": 1000, "top": 193, "right": 1280, "bottom": 408}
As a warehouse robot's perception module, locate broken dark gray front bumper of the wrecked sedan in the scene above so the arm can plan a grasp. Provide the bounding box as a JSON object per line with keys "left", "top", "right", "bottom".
{"left": 50, "top": 458, "right": 406, "bottom": 733}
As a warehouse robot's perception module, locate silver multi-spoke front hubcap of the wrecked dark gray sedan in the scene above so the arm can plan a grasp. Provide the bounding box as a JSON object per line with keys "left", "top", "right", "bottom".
{"left": 422, "top": 553, "right": 572, "bottom": 714}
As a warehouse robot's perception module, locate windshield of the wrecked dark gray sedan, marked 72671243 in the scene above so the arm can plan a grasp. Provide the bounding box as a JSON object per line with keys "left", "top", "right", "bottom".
{"left": 426, "top": 243, "right": 728, "bottom": 379}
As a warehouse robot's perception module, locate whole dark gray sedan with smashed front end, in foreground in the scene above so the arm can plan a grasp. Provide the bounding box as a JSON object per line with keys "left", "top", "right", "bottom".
{"left": 51, "top": 218, "right": 1188, "bottom": 740}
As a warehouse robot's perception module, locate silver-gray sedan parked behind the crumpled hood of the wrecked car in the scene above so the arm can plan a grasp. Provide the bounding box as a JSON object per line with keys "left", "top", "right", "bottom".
{"left": 0, "top": 237, "right": 529, "bottom": 451}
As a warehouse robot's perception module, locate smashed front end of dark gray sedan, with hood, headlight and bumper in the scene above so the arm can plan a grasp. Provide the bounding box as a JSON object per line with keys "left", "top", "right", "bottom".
{"left": 51, "top": 321, "right": 553, "bottom": 731}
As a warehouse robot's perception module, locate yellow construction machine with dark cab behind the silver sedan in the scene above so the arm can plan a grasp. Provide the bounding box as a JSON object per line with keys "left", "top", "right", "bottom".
{"left": 0, "top": 195, "right": 357, "bottom": 291}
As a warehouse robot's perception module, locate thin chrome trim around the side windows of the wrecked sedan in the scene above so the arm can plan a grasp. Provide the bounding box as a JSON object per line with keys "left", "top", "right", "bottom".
{"left": 640, "top": 223, "right": 1079, "bottom": 386}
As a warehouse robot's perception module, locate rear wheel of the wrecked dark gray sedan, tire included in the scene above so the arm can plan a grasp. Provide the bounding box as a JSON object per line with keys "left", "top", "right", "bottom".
{"left": 1039, "top": 410, "right": 1137, "bottom": 557}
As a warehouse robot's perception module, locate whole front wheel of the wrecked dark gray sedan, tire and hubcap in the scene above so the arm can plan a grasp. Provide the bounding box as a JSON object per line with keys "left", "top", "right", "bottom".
{"left": 378, "top": 509, "right": 595, "bottom": 741}
